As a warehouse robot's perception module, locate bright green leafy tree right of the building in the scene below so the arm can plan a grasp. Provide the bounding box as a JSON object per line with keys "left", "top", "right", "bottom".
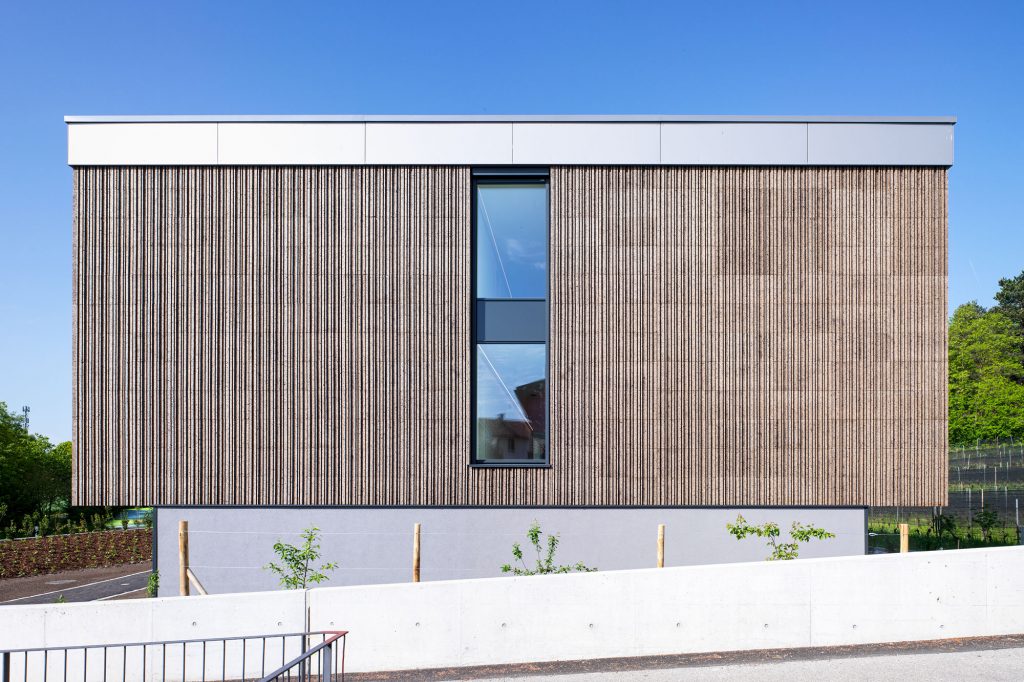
{"left": 949, "top": 301, "right": 1024, "bottom": 445}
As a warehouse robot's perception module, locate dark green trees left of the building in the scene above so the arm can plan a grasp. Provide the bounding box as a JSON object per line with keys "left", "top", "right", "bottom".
{"left": 0, "top": 402, "right": 71, "bottom": 518}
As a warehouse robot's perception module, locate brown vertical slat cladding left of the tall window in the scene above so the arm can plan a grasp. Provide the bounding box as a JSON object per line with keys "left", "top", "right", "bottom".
{"left": 74, "top": 168, "right": 470, "bottom": 505}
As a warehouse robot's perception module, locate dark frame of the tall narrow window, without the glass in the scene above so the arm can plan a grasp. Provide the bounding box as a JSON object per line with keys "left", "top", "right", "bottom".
{"left": 468, "top": 167, "right": 552, "bottom": 469}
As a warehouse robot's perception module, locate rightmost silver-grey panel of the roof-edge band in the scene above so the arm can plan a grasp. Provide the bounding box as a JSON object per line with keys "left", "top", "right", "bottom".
{"left": 807, "top": 123, "right": 953, "bottom": 166}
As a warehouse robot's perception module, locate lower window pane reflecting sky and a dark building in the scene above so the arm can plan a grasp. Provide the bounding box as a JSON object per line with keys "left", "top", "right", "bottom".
{"left": 476, "top": 343, "right": 547, "bottom": 462}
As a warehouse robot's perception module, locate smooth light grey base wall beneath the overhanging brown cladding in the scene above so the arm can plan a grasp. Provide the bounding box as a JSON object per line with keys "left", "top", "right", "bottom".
{"left": 156, "top": 507, "right": 865, "bottom": 596}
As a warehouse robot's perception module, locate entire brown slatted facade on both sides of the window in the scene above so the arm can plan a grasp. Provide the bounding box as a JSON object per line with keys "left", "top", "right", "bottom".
{"left": 74, "top": 167, "right": 947, "bottom": 506}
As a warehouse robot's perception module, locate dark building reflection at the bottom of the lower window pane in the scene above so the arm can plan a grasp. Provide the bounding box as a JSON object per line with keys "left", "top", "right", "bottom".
{"left": 476, "top": 379, "right": 547, "bottom": 460}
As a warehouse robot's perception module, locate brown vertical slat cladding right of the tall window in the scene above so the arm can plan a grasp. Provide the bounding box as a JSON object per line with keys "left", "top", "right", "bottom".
{"left": 552, "top": 168, "right": 947, "bottom": 505}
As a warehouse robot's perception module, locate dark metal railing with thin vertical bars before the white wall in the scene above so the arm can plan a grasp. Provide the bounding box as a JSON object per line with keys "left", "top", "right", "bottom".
{"left": 0, "top": 632, "right": 347, "bottom": 682}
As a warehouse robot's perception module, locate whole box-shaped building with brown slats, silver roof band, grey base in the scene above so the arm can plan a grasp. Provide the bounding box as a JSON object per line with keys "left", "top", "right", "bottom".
{"left": 67, "top": 116, "right": 954, "bottom": 593}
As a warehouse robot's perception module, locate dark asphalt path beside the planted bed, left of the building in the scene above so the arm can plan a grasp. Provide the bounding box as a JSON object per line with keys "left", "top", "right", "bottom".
{"left": 0, "top": 563, "right": 150, "bottom": 607}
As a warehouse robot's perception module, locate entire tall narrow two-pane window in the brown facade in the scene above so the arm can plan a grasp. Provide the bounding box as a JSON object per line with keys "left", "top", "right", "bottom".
{"left": 472, "top": 169, "right": 548, "bottom": 466}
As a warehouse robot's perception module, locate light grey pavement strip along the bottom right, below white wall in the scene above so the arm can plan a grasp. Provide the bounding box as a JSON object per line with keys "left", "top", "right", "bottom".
{"left": 483, "top": 648, "right": 1024, "bottom": 682}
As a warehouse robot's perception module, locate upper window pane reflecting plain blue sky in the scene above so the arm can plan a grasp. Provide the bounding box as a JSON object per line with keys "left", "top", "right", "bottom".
{"left": 476, "top": 183, "right": 548, "bottom": 298}
